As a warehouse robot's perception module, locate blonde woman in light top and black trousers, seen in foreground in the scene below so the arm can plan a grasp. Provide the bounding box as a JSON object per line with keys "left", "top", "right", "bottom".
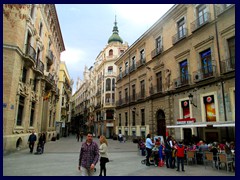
{"left": 99, "top": 135, "right": 109, "bottom": 176}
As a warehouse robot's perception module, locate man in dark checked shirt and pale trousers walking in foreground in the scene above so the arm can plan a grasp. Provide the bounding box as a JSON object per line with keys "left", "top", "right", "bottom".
{"left": 78, "top": 132, "right": 99, "bottom": 176}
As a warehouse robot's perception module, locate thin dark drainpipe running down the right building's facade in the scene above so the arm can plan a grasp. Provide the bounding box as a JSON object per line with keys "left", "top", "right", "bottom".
{"left": 213, "top": 4, "right": 229, "bottom": 139}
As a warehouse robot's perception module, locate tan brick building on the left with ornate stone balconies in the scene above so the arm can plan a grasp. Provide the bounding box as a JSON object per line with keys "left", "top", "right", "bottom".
{"left": 3, "top": 4, "right": 65, "bottom": 152}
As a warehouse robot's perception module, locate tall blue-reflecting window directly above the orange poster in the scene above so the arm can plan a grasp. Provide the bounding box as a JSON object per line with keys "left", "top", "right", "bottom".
{"left": 200, "top": 49, "right": 213, "bottom": 78}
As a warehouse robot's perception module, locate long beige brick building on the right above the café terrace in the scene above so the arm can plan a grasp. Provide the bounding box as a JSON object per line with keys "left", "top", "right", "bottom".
{"left": 115, "top": 4, "right": 235, "bottom": 142}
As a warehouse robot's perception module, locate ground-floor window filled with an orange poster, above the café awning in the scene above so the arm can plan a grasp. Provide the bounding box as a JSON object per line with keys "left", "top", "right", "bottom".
{"left": 203, "top": 95, "right": 216, "bottom": 122}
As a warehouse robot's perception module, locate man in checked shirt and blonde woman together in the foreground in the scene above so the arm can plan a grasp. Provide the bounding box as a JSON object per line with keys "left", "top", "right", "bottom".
{"left": 78, "top": 132, "right": 109, "bottom": 176}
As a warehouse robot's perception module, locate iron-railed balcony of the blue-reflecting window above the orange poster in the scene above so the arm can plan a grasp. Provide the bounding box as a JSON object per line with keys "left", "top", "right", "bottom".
{"left": 193, "top": 65, "right": 216, "bottom": 82}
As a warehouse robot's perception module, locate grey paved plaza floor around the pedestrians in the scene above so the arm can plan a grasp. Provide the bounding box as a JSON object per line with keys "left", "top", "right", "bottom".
{"left": 3, "top": 135, "right": 235, "bottom": 176}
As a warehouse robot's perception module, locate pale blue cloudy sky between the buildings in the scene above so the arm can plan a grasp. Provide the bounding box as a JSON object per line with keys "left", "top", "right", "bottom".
{"left": 56, "top": 4, "right": 173, "bottom": 93}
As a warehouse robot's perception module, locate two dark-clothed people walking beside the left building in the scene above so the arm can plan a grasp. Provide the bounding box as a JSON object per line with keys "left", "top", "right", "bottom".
{"left": 28, "top": 131, "right": 46, "bottom": 154}
